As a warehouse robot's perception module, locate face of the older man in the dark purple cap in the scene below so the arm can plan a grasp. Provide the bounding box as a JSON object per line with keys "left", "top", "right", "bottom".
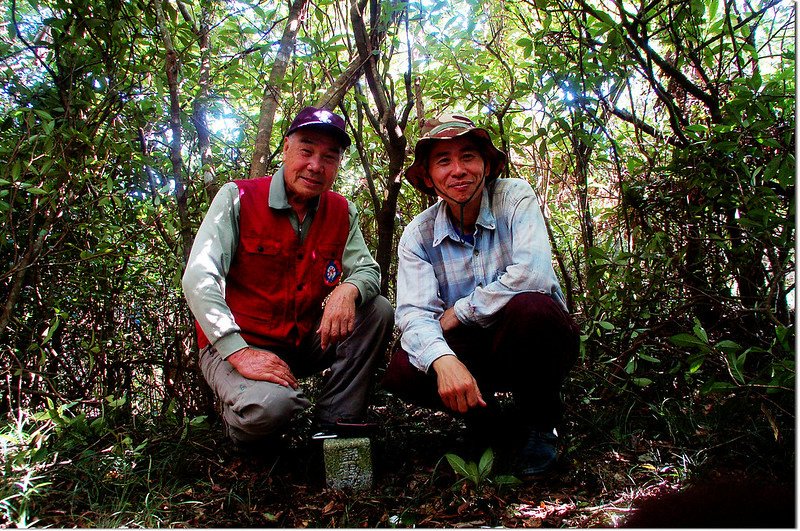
{"left": 283, "top": 128, "right": 342, "bottom": 202}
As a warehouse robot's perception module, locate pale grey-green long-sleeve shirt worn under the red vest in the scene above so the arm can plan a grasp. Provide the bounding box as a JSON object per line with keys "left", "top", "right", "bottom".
{"left": 183, "top": 167, "right": 381, "bottom": 358}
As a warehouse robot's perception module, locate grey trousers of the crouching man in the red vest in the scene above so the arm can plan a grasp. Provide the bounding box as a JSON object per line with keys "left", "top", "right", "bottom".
{"left": 200, "top": 295, "right": 394, "bottom": 443}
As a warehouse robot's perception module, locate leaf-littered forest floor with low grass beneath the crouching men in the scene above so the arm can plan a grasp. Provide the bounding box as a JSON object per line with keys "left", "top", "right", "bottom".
{"left": 0, "top": 376, "right": 794, "bottom": 528}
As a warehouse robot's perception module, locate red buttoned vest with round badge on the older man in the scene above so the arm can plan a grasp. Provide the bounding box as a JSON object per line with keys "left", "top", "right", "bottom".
{"left": 197, "top": 177, "right": 350, "bottom": 348}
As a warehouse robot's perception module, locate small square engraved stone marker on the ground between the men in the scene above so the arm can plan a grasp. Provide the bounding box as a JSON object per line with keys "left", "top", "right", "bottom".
{"left": 323, "top": 437, "right": 372, "bottom": 490}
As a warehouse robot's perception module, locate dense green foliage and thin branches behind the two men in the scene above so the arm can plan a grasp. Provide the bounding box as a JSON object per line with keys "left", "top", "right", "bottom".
{"left": 0, "top": 0, "right": 796, "bottom": 460}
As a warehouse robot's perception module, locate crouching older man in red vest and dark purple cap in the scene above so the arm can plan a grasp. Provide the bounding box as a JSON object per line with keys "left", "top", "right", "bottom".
{"left": 183, "top": 107, "right": 394, "bottom": 449}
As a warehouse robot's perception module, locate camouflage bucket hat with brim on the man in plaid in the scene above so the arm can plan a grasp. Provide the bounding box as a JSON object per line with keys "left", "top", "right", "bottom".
{"left": 406, "top": 114, "right": 508, "bottom": 196}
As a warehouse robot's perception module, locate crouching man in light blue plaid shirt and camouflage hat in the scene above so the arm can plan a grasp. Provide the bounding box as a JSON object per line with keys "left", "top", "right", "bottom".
{"left": 383, "top": 114, "right": 579, "bottom": 477}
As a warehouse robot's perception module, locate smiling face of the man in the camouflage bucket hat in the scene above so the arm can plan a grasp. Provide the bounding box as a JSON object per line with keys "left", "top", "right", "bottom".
{"left": 425, "top": 137, "right": 488, "bottom": 206}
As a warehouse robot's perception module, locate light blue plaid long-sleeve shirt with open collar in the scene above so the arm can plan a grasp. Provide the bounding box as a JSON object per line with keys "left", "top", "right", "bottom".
{"left": 395, "top": 178, "right": 567, "bottom": 372}
